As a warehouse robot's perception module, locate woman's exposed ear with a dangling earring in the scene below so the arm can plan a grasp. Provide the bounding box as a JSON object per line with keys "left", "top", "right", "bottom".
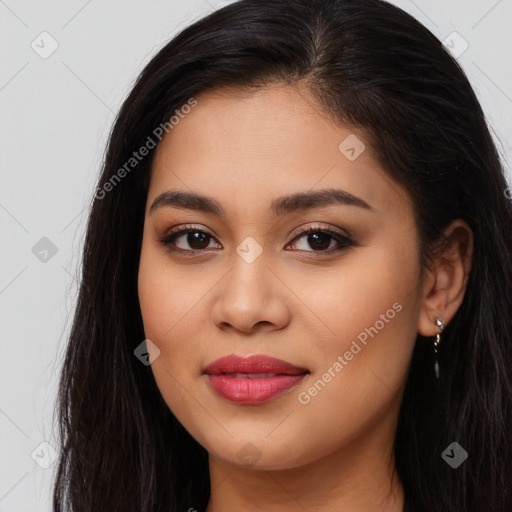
{"left": 418, "top": 219, "right": 473, "bottom": 337}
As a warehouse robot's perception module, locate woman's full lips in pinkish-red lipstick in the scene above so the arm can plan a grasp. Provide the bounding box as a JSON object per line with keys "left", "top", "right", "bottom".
{"left": 204, "top": 355, "right": 309, "bottom": 404}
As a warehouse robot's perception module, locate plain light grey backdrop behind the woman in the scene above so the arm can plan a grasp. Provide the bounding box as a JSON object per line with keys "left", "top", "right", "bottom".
{"left": 0, "top": 0, "right": 512, "bottom": 512}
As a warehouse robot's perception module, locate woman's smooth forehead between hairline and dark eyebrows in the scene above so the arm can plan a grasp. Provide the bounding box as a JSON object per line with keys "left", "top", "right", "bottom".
{"left": 148, "top": 86, "right": 410, "bottom": 220}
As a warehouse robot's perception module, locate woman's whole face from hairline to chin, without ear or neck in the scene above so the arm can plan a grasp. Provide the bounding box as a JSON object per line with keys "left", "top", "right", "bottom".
{"left": 139, "top": 86, "right": 421, "bottom": 469}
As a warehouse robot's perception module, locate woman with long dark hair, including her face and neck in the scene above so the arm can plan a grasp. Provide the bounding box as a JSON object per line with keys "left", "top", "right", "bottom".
{"left": 54, "top": 0, "right": 512, "bottom": 512}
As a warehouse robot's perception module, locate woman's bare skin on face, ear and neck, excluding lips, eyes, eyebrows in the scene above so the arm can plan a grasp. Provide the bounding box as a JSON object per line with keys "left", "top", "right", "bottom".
{"left": 139, "top": 86, "right": 473, "bottom": 512}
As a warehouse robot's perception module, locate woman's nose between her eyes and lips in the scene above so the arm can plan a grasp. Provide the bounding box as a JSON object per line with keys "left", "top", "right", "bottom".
{"left": 212, "top": 256, "right": 290, "bottom": 334}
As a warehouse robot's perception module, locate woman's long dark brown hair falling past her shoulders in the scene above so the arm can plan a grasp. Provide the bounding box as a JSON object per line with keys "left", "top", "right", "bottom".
{"left": 53, "top": 0, "right": 512, "bottom": 512}
